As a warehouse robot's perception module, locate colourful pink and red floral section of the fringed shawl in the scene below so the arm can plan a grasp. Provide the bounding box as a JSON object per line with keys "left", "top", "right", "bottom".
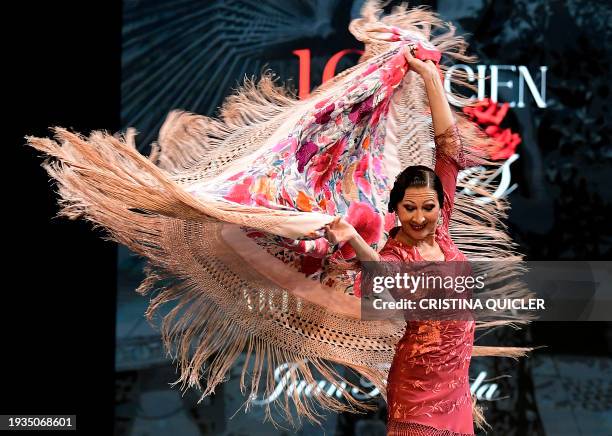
{"left": 213, "top": 50, "right": 408, "bottom": 286}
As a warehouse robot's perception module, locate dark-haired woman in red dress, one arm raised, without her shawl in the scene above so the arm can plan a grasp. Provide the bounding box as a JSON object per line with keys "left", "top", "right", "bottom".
{"left": 326, "top": 49, "right": 475, "bottom": 436}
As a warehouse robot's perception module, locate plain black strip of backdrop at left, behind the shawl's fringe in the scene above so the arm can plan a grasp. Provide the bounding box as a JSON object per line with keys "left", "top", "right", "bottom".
{"left": 5, "top": 1, "right": 121, "bottom": 435}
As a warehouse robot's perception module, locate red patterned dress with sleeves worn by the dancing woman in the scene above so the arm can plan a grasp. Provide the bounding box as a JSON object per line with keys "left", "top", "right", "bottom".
{"left": 358, "top": 126, "right": 475, "bottom": 436}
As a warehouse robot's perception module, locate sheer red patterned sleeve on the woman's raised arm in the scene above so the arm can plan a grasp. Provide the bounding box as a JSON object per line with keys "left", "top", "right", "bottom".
{"left": 434, "top": 124, "right": 466, "bottom": 232}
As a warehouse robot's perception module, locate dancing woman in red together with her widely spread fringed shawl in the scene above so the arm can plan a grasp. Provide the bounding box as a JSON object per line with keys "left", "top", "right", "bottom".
{"left": 26, "top": 1, "right": 528, "bottom": 435}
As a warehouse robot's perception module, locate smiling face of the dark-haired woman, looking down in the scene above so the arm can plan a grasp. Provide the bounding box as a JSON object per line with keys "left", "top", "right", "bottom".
{"left": 396, "top": 186, "right": 440, "bottom": 241}
